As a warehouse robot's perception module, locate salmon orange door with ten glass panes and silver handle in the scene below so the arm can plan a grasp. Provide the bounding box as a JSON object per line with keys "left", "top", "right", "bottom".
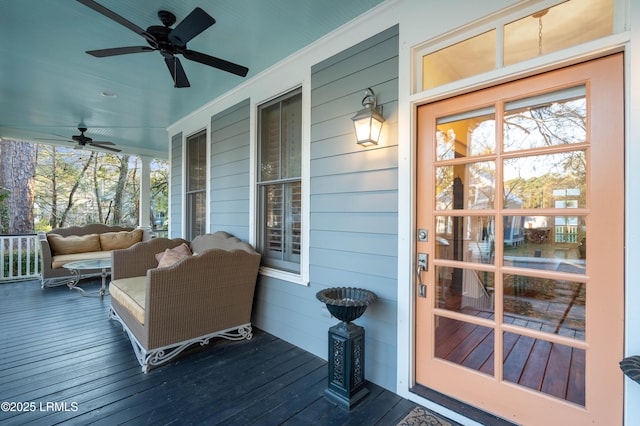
{"left": 415, "top": 54, "right": 624, "bottom": 425}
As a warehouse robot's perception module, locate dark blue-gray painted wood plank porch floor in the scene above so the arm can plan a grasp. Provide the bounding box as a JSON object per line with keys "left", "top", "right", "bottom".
{"left": 0, "top": 281, "right": 424, "bottom": 426}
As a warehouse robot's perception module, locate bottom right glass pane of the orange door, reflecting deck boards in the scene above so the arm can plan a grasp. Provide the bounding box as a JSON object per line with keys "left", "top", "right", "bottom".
{"left": 503, "top": 332, "right": 585, "bottom": 405}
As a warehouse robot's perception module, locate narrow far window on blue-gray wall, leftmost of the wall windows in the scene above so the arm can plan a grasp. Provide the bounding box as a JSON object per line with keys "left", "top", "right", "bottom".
{"left": 186, "top": 130, "right": 207, "bottom": 240}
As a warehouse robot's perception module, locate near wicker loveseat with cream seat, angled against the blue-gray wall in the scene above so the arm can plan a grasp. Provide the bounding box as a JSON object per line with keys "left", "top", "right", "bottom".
{"left": 109, "top": 231, "right": 261, "bottom": 372}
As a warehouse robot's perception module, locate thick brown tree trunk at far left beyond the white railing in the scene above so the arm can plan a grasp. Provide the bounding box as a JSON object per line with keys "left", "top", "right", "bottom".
{"left": 0, "top": 139, "right": 36, "bottom": 234}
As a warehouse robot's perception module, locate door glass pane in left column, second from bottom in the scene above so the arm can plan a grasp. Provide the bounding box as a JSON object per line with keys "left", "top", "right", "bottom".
{"left": 436, "top": 266, "right": 495, "bottom": 315}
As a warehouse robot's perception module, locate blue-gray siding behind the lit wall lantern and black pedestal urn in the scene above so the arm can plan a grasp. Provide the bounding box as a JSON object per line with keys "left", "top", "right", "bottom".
{"left": 254, "top": 22, "right": 398, "bottom": 389}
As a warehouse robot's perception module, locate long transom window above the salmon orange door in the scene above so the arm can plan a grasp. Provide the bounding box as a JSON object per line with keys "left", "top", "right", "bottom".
{"left": 416, "top": 0, "right": 614, "bottom": 90}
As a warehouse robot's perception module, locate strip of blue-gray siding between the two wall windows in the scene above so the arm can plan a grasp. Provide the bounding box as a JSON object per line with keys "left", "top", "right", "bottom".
{"left": 209, "top": 99, "right": 251, "bottom": 241}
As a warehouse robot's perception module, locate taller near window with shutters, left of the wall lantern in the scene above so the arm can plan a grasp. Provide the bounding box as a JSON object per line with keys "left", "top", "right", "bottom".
{"left": 257, "top": 89, "right": 302, "bottom": 273}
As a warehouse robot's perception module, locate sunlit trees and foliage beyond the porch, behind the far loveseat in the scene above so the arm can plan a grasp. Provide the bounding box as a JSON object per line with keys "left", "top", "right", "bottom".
{"left": 34, "top": 145, "right": 168, "bottom": 230}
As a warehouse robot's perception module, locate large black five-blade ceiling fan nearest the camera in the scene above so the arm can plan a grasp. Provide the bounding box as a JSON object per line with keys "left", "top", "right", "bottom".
{"left": 77, "top": 0, "right": 249, "bottom": 87}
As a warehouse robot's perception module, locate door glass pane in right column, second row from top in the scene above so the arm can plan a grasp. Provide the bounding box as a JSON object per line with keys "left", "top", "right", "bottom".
{"left": 504, "top": 151, "right": 587, "bottom": 209}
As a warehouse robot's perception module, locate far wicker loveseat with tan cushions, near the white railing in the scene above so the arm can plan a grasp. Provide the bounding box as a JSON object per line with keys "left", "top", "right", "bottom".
{"left": 37, "top": 223, "right": 150, "bottom": 288}
